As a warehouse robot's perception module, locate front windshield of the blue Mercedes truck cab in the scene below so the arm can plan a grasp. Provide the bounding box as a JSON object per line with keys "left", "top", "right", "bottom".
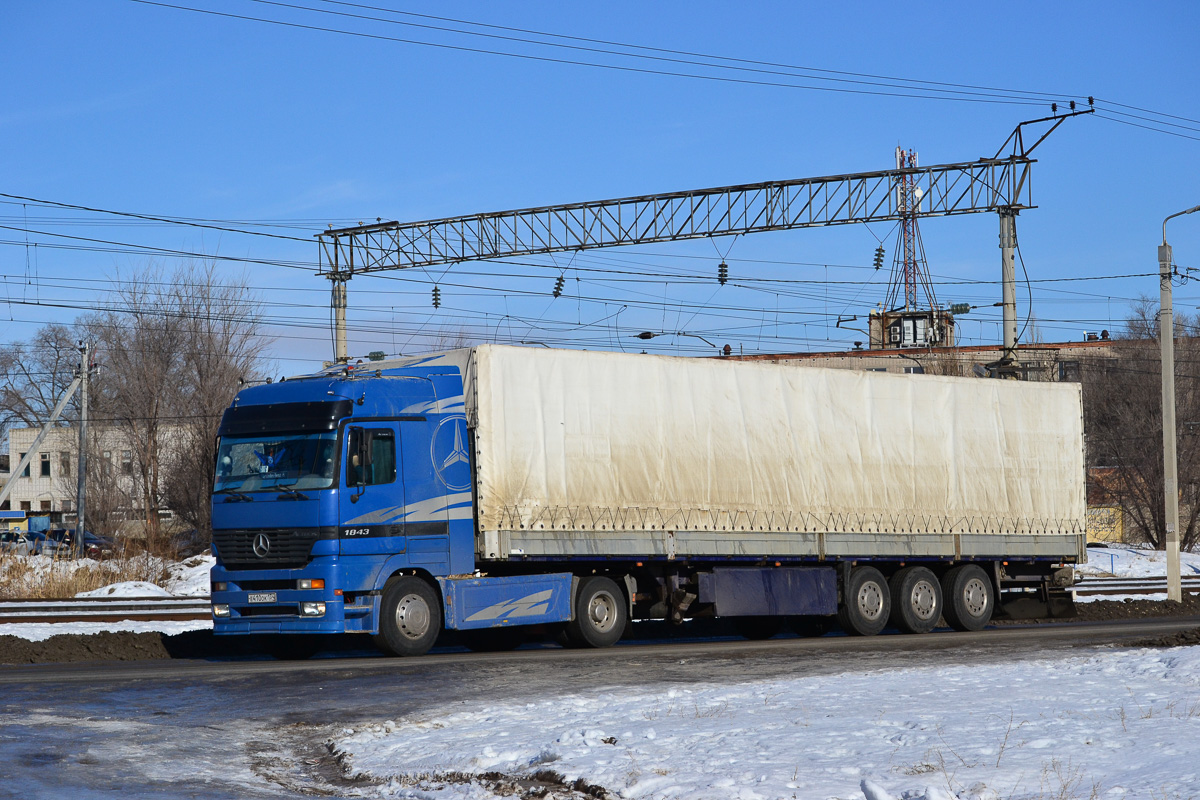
{"left": 212, "top": 431, "right": 337, "bottom": 492}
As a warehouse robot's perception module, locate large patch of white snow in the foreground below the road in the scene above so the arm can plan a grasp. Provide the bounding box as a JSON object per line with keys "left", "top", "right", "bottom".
{"left": 334, "top": 648, "right": 1200, "bottom": 800}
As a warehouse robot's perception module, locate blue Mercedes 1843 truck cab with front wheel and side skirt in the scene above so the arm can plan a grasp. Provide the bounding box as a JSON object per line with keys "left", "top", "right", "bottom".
{"left": 211, "top": 357, "right": 578, "bottom": 655}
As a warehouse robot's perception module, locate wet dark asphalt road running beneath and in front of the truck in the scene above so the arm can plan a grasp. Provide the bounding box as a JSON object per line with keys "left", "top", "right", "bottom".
{"left": 0, "top": 618, "right": 1200, "bottom": 800}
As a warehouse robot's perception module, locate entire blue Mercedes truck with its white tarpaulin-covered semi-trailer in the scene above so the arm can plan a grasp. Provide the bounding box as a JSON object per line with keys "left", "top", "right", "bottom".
{"left": 212, "top": 345, "right": 1085, "bottom": 654}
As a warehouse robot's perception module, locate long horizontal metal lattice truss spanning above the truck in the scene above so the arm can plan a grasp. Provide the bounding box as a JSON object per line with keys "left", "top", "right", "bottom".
{"left": 319, "top": 155, "right": 1036, "bottom": 275}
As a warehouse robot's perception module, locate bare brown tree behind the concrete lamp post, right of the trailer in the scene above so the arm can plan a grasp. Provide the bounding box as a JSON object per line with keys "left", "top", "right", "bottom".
{"left": 1081, "top": 299, "right": 1200, "bottom": 549}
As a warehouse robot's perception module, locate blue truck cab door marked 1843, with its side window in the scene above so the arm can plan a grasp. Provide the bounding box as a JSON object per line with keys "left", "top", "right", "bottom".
{"left": 338, "top": 422, "right": 406, "bottom": 555}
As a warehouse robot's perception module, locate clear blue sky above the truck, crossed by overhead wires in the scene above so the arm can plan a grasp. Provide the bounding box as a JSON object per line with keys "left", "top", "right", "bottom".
{"left": 0, "top": 0, "right": 1200, "bottom": 372}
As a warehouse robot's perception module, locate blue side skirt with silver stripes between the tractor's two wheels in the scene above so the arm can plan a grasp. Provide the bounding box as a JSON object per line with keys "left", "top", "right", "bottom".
{"left": 438, "top": 572, "right": 575, "bottom": 631}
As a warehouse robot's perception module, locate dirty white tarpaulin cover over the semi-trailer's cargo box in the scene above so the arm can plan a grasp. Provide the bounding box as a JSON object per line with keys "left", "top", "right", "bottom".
{"left": 466, "top": 345, "right": 1085, "bottom": 534}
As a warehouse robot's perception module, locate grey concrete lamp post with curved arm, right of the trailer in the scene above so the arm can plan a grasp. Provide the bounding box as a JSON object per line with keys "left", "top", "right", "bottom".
{"left": 1158, "top": 205, "right": 1200, "bottom": 602}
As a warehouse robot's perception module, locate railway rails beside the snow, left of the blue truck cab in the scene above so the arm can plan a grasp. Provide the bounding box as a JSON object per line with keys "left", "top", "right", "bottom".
{"left": 0, "top": 596, "right": 212, "bottom": 624}
